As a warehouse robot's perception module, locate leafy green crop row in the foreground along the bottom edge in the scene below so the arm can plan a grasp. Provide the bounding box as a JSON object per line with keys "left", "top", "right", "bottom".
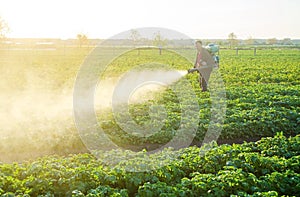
{"left": 0, "top": 133, "right": 300, "bottom": 197}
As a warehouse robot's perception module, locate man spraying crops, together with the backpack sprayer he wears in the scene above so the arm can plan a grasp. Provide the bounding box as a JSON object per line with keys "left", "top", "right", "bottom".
{"left": 188, "top": 40, "right": 219, "bottom": 92}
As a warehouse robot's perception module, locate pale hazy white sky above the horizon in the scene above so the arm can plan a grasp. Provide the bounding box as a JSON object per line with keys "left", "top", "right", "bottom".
{"left": 0, "top": 0, "right": 300, "bottom": 39}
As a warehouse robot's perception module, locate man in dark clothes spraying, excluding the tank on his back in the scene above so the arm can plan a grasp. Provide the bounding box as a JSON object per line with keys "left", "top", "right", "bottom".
{"left": 189, "top": 40, "right": 216, "bottom": 92}
